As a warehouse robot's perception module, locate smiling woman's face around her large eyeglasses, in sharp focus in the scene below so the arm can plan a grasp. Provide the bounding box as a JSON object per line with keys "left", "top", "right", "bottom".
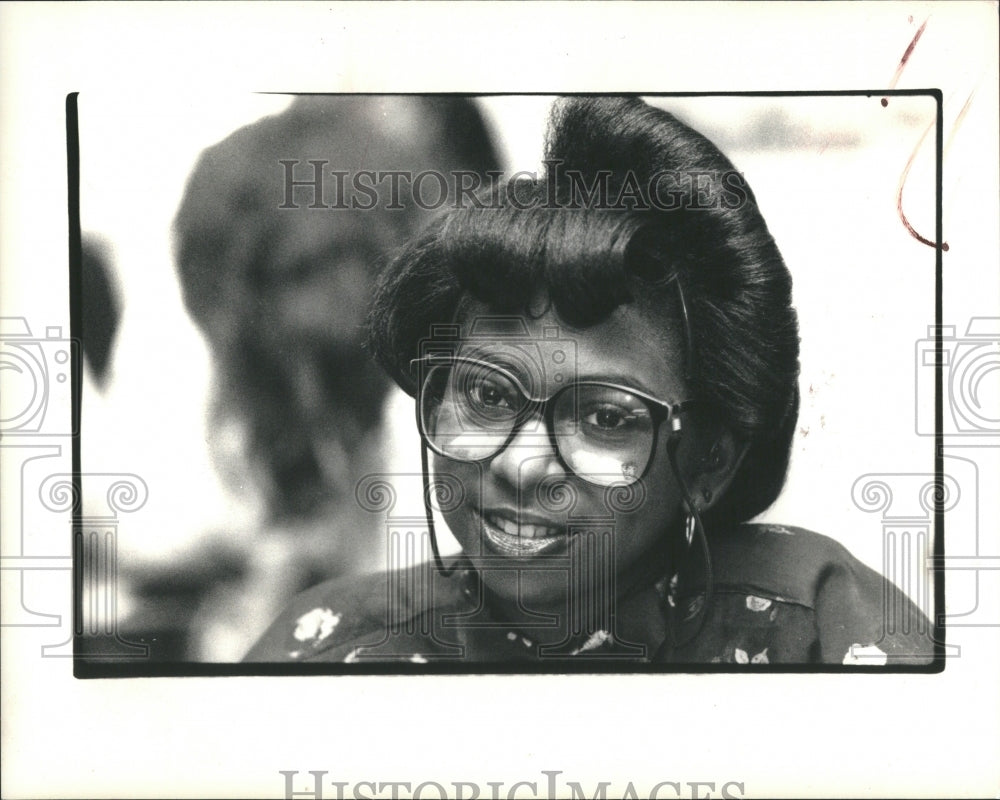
{"left": 433, "top": 296, "right": 694, "bottom": 613}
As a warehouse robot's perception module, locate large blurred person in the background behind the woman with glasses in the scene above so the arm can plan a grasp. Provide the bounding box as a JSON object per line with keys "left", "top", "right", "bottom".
{"left": 126, "top": 95, "right": 498, "bottom": 661}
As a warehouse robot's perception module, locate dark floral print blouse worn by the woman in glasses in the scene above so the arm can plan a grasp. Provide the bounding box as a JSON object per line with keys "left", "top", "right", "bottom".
{"left": 245, "top": 524, "right": 934, "bottom": 672}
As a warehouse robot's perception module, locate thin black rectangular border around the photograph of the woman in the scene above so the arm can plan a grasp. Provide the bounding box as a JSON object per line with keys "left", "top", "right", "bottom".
{"left": 65, "top": 89, "right": 947, "bottom": 679}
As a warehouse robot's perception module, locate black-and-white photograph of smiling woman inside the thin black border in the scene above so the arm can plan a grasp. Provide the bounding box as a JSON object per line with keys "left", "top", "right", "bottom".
{"left": 80, "top": 93, "right": 944, "bottom": 674}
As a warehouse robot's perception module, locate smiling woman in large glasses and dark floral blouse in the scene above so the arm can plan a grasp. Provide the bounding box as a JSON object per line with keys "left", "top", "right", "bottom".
{"left": 247, "top": 98, "right": 933, "bottom": 669}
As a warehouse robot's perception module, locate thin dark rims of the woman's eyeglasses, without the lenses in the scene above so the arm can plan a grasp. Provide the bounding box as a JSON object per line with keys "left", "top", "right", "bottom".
{"left": 410, "top": 353, "right": 699, "bottom": 486}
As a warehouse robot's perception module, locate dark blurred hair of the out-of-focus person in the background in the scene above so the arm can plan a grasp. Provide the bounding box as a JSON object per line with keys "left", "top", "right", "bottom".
{"left": 174, "top": 95, "right": 498, "bottom": 521}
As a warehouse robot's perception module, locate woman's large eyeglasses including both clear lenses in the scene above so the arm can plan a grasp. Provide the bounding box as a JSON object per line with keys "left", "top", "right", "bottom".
{"left": 411, "top": 354, "right": 692, "bottom": 486}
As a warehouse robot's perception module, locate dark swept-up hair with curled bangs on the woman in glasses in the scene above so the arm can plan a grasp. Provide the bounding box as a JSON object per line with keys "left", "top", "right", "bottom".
{"left": 369, "top": 97, "right": 799, "bottom": 522}
